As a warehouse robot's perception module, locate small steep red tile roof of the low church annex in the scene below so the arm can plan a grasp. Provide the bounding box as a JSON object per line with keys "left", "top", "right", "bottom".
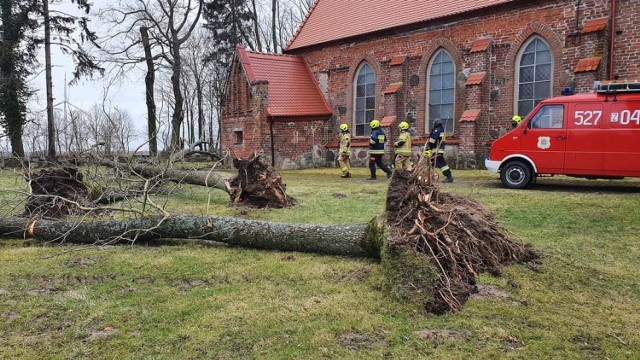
{"left": 236, "top": 45, "right": 333, "bottom": 116}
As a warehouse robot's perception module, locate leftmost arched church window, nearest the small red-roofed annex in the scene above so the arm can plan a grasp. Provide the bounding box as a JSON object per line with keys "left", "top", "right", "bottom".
{"left": 353, "top": 62, "right": 376, "bottom": 136}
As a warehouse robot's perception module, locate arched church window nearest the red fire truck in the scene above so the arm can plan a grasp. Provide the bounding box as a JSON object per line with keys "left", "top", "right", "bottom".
{"left": 515, "top": 36, "right": 553, "bottom": 117}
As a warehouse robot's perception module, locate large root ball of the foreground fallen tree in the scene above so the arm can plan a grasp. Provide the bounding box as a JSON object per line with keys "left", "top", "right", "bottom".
{"left": 383, "top": 160, "right": 538, "bottom": 314}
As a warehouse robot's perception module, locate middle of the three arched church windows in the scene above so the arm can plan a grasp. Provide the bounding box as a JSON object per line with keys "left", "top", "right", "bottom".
{"left": 426, "top": 49, "right": 456, "bottom": 132}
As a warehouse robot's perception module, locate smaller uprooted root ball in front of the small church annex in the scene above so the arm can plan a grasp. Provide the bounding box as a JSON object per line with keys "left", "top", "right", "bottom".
{"left": 226, "top": 156, "right": 294, "bottom": 208}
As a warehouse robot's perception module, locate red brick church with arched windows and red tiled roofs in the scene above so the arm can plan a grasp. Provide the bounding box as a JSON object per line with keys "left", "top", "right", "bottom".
{"left": 221, "top": 0, "right": 640, "bottom": 169}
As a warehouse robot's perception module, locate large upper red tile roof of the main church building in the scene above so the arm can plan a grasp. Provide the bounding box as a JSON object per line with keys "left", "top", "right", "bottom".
{"left": 285, "top": 0, "right": 514, "bottom": 51}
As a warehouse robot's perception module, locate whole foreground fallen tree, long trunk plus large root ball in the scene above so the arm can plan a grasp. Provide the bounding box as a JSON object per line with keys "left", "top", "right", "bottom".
{"left": 0, "top": 159, "right": 538, "bottom": 314}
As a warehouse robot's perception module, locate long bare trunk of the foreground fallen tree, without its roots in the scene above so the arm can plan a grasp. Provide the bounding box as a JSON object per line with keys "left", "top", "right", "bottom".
{"left": 0, "top": 215, "right": 383, "bottom": 258}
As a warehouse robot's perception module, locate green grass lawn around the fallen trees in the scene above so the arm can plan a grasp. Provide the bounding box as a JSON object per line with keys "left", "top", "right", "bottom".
{"left": 0, "top": 169, "right": 640, "bottom": 359}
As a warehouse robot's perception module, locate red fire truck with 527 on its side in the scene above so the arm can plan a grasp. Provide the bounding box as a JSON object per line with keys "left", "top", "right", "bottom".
{"left": 485, "top": 81, "right": 640, "bottom": 189}
